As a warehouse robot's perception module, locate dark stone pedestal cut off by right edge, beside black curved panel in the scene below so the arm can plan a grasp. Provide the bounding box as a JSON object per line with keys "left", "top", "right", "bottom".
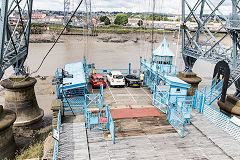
{"left": 217, "top": 95, "right": 240, "bottom": 118}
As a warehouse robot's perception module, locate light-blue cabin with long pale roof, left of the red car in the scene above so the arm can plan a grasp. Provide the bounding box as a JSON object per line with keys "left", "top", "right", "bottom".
{"left": 55, "top": 57, "right": 93, "bottom": 114}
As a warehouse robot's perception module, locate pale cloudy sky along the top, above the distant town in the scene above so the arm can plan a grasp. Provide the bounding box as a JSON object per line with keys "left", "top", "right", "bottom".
{"left": 0, "top": 0, "right": 232, "bottom": 15}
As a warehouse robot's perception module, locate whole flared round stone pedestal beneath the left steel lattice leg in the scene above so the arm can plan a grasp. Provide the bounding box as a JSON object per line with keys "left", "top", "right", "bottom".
{"left": 1, "top": 76, "right": 43, "bottom": 126}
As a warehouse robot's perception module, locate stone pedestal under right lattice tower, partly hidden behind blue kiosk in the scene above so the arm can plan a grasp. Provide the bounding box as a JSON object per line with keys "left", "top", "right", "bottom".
{"left": 178, "top": 72, "right": 202, "bottom": 96}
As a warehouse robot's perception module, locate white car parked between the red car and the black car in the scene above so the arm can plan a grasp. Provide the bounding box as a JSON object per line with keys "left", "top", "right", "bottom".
{"left": 107, "top": 71, "right": 125, "bottom": 86}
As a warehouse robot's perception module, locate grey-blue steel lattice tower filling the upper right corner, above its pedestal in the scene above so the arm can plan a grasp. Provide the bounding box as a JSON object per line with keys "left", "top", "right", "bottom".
{"left": 182, "top": 0, "right": 240, "bottom": 96}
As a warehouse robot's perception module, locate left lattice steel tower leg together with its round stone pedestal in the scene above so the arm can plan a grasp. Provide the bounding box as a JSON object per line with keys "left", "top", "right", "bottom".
{"left": 0, "top": 0, "right": 43, "bottom": 129}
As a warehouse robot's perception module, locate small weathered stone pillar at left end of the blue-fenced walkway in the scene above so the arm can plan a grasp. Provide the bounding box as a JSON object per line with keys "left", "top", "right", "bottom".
{"left": 51, "top": 99, "right": 63, "bottom": 129}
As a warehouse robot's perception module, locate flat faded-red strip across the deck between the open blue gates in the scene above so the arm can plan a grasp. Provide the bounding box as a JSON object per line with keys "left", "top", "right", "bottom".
{"left": 111, "top": 108, "right": 165, "bottom": 119}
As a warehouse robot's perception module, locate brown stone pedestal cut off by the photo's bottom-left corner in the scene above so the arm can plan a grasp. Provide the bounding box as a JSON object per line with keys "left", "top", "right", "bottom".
{"left": 0, "top": 106, "right": 17, "bottom": 159}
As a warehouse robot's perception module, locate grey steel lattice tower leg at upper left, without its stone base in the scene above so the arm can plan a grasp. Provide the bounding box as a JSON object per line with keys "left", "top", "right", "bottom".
{"left": 0, "top": 0, "right": 33, "bottom": 79}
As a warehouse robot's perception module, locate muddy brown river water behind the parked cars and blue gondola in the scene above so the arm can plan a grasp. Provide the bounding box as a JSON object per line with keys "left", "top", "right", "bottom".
{"left": 4, "top": 33, "right": 234, "bottom": 93}
